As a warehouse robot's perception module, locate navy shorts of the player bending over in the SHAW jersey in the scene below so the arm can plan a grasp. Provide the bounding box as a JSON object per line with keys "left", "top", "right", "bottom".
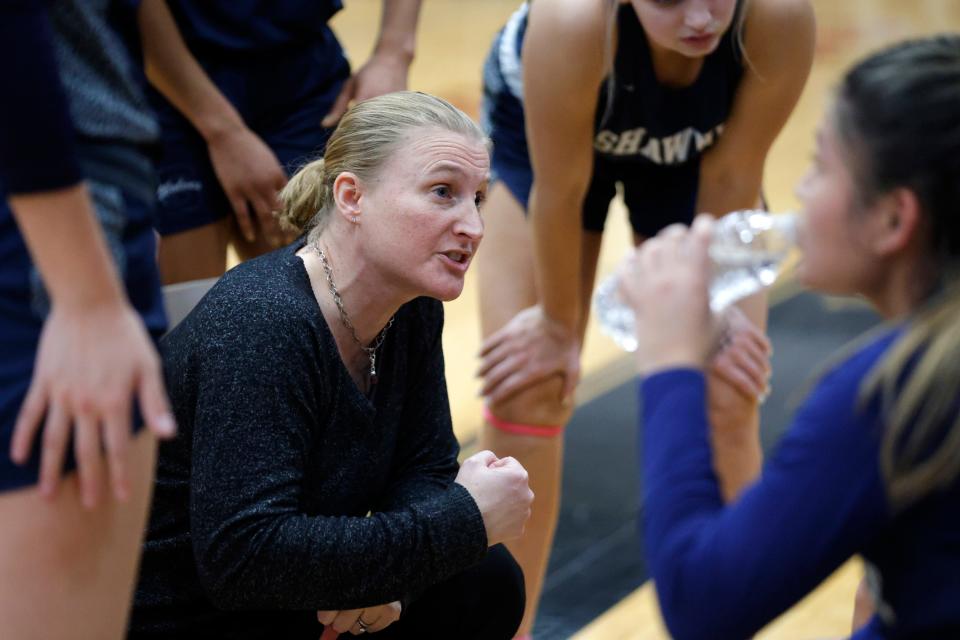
{"left": 481, "top": 3, "right": 700, "bottom": 237}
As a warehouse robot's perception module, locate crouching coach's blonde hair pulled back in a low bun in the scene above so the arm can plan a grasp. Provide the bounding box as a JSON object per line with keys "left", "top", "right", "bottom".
{"left": 279, "top": 91, "right": 490, "bottom": 240}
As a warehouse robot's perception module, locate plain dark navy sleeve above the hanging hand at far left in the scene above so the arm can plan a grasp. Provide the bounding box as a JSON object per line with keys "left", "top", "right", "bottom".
{"left": 0, "top": 0, "right": 81, "bottom": 194}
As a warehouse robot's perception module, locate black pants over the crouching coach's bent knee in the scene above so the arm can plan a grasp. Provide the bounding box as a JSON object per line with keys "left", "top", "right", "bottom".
{"left": 340, "top": 545, "right": 526, "bottom": 640}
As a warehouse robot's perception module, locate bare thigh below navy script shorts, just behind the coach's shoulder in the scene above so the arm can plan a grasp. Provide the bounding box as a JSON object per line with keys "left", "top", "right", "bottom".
{"left": 160, "top": 217, "right": 231, "bottom": 284}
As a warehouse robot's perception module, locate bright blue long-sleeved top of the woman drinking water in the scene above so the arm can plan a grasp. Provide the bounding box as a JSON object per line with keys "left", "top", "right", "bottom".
{"left": 640, "top": 330, "right": 960, "bottom": 640}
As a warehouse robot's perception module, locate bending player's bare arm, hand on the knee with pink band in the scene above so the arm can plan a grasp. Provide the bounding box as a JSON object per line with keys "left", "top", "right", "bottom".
{"left": 482, "top": 0, "right": 614, "bottom": 401}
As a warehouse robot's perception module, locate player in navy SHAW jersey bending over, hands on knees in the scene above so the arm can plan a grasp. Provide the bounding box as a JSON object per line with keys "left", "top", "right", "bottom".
{"left": 479, "top": 0, "right": 814, "bottom": 632}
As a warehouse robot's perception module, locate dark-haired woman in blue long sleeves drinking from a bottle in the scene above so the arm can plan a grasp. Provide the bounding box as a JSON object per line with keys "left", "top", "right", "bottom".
{"left": 624, "top": 35, "right": 960, "bottom": 640}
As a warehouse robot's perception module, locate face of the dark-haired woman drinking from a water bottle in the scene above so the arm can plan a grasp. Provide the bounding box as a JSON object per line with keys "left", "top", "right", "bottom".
{"left": 796, "top": 117, "right": 877, "bottom": 295}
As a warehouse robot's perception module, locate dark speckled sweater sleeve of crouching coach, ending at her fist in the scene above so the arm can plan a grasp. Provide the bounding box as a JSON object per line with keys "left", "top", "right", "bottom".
{"left": 190, "top": 304, "right": 482, "bottom": 610}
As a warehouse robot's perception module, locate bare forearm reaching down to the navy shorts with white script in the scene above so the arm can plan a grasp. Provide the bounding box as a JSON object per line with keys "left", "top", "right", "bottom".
{"left": 138, "top": 0, "right": 246, "bottom": 141}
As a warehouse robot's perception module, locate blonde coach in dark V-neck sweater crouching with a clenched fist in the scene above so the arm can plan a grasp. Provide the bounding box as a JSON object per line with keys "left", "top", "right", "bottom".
{"left": 131, "top": 92, "right": 533, "bottom": 640}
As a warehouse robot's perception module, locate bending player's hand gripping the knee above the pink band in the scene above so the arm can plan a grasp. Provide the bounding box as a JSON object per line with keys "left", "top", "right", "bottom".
{"left": 477, "top": 306, "right": 580, "bottom": 403}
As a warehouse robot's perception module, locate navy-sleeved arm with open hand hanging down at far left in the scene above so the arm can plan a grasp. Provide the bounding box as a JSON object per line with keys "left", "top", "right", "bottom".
{"left": 0, "top": 0, "right": 174, "bottom": 507}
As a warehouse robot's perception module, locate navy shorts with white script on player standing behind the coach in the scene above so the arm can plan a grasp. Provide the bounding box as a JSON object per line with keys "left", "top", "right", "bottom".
{"left": 156, "top": 28, "right": 350, "bottom": 235}
